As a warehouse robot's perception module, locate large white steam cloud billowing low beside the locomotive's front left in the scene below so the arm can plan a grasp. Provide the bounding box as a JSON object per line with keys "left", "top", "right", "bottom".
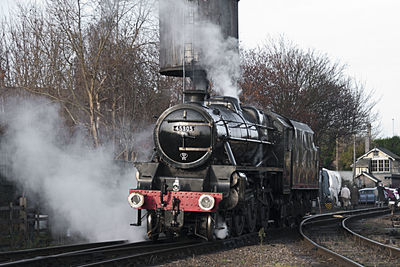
{"left": 0, "top": 99, "right": 145, "bottom": 241}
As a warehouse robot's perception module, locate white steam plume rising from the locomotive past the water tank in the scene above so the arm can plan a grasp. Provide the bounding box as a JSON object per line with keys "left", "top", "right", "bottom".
{"left": 159, "top": 0, "right": 241, "bottom": 98}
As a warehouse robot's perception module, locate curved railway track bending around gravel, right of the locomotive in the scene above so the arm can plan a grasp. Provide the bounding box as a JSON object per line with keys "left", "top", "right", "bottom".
{"left": 300, "top": 208, "right": 400, "bottom": 266}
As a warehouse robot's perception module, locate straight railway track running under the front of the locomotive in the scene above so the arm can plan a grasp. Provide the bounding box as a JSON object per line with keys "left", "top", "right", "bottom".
{"left": 0, "top": 233, "right": 258, "bottom": 266}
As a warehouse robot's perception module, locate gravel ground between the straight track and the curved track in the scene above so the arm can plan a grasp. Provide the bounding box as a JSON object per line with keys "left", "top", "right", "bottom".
{"left": 158, "top": 233, "right": 328, "bottom": 267}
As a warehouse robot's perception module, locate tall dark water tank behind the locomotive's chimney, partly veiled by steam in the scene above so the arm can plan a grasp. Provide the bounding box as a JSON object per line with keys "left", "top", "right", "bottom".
{"left": 160, "top": 0, "right": 239, "bottom": 77}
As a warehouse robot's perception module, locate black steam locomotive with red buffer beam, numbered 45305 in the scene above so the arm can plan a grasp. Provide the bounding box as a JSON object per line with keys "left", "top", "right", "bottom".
{"left": 128, "top": 90, "right": 319, "bottom": 240}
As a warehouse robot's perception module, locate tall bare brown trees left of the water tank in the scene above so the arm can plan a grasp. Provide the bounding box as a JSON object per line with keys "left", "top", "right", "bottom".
{"left": 0, "top": 0, "right": 174, "bottom": 157}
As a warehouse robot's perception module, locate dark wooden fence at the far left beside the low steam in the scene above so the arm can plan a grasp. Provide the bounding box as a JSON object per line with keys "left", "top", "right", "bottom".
{"left": 0, "top": 197, "right": 49, "bottom": 250}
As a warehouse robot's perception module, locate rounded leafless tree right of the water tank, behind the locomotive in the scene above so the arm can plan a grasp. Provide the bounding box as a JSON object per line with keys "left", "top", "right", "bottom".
{"left": 241, "top": 39, "right": 375, "bottom": 168}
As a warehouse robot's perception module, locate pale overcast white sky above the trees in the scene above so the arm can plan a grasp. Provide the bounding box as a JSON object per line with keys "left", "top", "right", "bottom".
{"left": 0, "top": 0, "right": 400, "bottom": 137}
